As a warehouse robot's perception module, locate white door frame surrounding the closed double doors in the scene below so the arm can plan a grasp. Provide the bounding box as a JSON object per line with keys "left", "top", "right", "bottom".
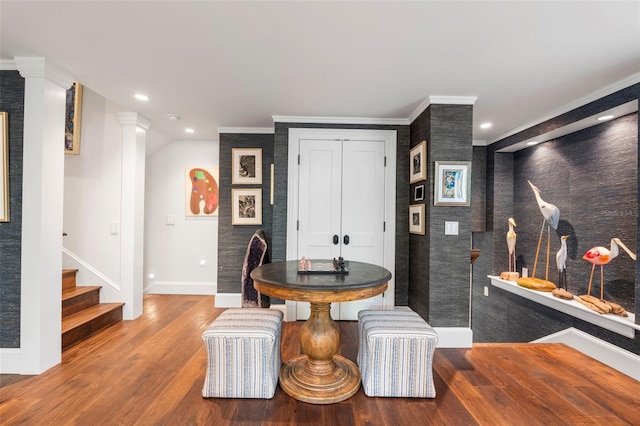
{"left": 286, "top": 128, "right": 397, "bottom": 321}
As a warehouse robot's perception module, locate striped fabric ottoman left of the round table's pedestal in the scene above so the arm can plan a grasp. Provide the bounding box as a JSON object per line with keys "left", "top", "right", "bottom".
{"left": 202, "top": 308, "right": 283, "bottom": 399}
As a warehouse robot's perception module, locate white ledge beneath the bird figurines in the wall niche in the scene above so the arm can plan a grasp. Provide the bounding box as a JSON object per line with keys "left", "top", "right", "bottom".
{"left": 487, "top": 275, "right": 640, "bottom": 339}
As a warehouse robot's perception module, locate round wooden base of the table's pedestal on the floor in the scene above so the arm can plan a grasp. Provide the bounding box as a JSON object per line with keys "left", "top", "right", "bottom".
{"left": 280, "top": 355, "right": 360, "bottom": 404}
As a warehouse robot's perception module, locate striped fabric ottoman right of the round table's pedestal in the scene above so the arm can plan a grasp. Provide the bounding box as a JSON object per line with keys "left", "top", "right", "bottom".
{"left": 357, "top": 308, "right": 438, "bottom": 398}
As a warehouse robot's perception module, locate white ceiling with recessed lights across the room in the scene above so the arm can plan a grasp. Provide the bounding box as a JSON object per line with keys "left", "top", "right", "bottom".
{"left": 0, "top": 0, "right": 640, "bottom": 155}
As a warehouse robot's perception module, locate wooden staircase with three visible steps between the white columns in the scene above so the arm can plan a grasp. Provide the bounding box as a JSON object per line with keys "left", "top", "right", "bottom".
{"left": 62, "top": 269, "right": 124, "bottom": 352}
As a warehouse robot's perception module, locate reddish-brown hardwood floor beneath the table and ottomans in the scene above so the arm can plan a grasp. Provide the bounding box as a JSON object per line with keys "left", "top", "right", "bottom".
{"left": 0, "top": 295, "right": 640, "bottom": 425}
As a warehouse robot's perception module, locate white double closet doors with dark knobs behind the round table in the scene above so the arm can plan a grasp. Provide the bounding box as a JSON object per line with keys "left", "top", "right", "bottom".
{"left": 296, "top": 139, "right": 385, "bottom": 320}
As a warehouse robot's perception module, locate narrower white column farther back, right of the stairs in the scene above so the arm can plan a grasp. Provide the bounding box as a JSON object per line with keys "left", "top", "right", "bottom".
{"left": 118, "top": 112, "right": 149, "bottom": 320}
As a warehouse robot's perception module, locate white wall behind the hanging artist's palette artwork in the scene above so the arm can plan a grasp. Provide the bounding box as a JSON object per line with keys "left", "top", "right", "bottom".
{"left": 144, "top": 141, "right": 219, "bottom": 294}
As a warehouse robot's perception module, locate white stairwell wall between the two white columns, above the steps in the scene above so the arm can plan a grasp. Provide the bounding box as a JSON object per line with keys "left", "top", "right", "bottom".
{"left": 63, "top": 87, "right": 122, "bottom": 302}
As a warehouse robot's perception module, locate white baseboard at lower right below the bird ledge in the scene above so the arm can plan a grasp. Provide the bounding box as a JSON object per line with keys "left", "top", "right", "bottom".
{"left": 532, "top": 327, "right": 640, "bottom": 380}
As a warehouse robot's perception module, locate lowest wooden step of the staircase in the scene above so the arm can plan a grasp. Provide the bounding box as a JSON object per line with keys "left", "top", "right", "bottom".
{"left": 62, "top": 303, "right": 124, "bottom": 352}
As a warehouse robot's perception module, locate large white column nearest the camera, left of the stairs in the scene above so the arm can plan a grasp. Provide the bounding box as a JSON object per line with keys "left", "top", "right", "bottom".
{"left": 15, "top": 57, "right": 73, "bottom": 374}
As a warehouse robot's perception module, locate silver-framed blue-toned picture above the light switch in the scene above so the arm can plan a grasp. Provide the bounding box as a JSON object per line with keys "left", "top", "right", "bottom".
{"left": 433, "top": 161, "right": 471, "bottom": 206}
